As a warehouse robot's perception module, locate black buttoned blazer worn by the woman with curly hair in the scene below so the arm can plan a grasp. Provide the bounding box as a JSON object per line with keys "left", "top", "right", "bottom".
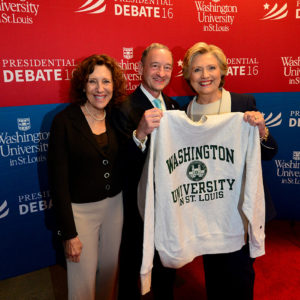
{"left": 48, "top": 104, "right": 121, "bottom": 239}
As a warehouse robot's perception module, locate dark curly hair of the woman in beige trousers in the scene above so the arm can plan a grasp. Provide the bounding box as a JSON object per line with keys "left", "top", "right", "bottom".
{"left": 70, "top": 54, "right": 126, "bottom": 105}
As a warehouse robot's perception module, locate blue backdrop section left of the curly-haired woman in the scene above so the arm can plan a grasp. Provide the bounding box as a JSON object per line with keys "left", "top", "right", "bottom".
{"left": 0, "top": 105, "right": 64, "bottom": 279}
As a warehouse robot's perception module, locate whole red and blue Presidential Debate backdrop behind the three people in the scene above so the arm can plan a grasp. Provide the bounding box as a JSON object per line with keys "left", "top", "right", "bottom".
{"left": 0, "top": 0, "right": 300, "bottom": 279}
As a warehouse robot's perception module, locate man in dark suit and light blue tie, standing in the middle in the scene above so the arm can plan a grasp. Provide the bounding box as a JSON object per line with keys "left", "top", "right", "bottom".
{"left": 113, "top": 43, "right": 179, "bottom": 300}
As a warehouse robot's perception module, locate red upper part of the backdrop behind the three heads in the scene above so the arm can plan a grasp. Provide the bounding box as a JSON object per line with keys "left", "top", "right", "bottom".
{"left": 0, "top": 0, "right": 300, "bottom": 106}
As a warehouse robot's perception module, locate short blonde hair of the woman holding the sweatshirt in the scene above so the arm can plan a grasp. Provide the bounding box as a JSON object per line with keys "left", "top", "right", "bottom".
{"left": 183, "top": 42, "right": 228, "bottom": 87}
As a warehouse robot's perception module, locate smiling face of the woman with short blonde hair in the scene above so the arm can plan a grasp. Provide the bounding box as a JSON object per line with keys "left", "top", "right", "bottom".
{"left": 190, "top": 53, "right": 222, "bottom": 102}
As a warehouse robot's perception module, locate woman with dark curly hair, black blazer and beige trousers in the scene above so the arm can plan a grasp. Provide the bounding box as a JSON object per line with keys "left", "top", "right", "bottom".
{"left": 48, "top": 55, "right": 125, "bottom": 300}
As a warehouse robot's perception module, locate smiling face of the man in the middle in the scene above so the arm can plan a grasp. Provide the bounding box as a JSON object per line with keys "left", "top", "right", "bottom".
{"left": 141, "top": 48, "right": 173, "bottom": 98}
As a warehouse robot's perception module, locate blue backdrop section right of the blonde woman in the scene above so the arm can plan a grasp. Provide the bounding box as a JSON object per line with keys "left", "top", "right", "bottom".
{"left": 253, "top": 93, "right": 300, "bottom": 220}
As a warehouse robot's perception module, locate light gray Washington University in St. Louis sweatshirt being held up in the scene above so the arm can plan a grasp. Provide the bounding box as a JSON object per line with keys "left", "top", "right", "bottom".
{"left": 138, "top": 111, "right": 265, "bottom": 294}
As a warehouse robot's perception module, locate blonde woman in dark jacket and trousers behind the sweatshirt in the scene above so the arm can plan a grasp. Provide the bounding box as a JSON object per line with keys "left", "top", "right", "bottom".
{"left": 183, "top": 42, "right": 277, "bottom": 300}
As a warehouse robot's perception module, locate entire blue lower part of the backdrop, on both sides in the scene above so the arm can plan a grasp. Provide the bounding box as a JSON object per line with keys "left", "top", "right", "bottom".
{"left": 0, "top": 93, "right": 300, "bottom": 279}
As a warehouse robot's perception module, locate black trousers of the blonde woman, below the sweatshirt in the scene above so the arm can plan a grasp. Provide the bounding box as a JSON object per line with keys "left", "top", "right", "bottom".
{"left": 203, "top": 244, "right": 255, "bottom": 300}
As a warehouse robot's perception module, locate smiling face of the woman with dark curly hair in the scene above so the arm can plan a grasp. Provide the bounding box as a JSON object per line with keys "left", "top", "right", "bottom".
{"left": 86, "top": 65, "right": 113, "bottom": 111}
